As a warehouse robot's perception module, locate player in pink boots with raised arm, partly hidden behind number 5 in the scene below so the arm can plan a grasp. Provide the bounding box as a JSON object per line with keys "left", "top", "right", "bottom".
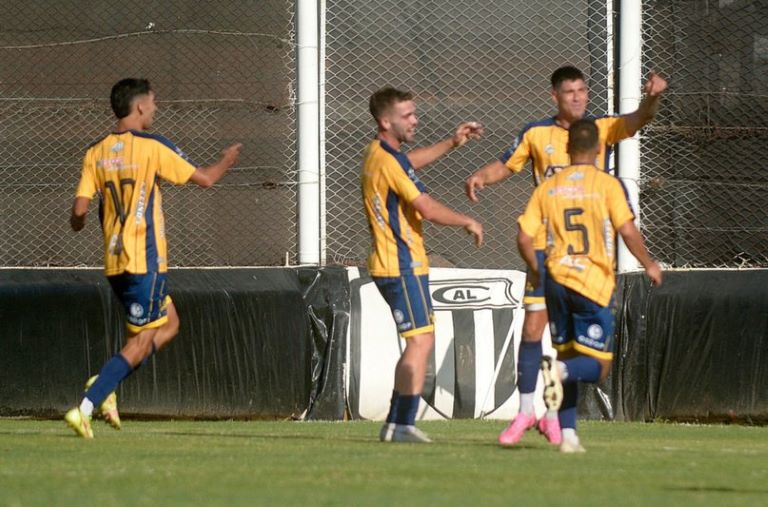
{"left": 465, "top": 66, "right": 667, "bottom": 445}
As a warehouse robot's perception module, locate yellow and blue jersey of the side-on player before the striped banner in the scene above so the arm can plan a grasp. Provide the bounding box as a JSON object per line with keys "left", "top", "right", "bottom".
{"left": 360, "top": 139, "right": 429, "bottom": 277}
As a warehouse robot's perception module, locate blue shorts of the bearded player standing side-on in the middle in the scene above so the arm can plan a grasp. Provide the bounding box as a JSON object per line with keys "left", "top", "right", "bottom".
{"left": 371, "top": 275, "right": 435, "bottom": 338}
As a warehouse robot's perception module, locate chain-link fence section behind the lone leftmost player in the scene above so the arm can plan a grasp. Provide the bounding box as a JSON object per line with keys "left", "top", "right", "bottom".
{"left": 0, "top": 0, "right": 296, "bottom": 266}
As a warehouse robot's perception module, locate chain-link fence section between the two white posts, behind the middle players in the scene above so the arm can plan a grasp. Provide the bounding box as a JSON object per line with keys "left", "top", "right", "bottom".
{"left": 326, "top": 0, "right": 611, "bottom": 268}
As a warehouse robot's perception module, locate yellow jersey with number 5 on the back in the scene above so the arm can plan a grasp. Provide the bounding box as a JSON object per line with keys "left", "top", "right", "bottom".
{"left": 518, "top": 165, "right": 634, "bottom": 306}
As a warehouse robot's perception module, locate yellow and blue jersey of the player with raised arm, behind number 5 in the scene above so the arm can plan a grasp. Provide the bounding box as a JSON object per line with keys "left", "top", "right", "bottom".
{"left": 500, "top": 116, "right": 629, "bottom": 186}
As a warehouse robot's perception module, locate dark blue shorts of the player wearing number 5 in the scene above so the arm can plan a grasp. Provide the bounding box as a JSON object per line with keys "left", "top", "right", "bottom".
{"left": 545, "top": 277, "right": 615, "bottom": 360}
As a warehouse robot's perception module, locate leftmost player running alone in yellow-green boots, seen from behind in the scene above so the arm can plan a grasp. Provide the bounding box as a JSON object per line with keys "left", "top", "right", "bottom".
{"left": 64, "top": 78, "right": 242, "bottom": 438}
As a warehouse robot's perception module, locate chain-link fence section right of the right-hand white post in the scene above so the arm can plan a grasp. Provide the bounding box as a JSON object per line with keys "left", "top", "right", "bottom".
{"left": 640, "top": 0, "right": 768, "bottom": 267}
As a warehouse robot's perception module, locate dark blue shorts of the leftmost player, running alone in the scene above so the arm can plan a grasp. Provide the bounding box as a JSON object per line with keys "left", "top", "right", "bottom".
{"left": 107, "top": 273, "right": 171, "bottom": 333}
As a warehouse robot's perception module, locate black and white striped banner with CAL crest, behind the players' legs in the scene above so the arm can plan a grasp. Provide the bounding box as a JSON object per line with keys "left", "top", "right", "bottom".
{"left": 346, "top": 268, "right": 550, "bottom": 420}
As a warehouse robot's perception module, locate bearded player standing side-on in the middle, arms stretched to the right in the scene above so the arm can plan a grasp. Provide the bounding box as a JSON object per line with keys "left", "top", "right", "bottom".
{"left": 360, "top": 88, "right": 483, "bottom": 443}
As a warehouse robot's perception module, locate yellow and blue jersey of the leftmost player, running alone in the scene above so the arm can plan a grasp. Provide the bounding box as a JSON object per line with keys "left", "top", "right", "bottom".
{"left": 76, "top": 130, "right": 196, "bottom": 276}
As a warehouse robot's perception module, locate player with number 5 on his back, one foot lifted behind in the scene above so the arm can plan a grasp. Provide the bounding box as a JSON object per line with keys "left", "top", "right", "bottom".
{"left": 517, "top": 119, "right": 662, "bottom": 453}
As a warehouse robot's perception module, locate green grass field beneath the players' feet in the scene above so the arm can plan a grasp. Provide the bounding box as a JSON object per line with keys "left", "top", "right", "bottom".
{"left": 0, "top": 419, "right": 768, "bottom": 507}
